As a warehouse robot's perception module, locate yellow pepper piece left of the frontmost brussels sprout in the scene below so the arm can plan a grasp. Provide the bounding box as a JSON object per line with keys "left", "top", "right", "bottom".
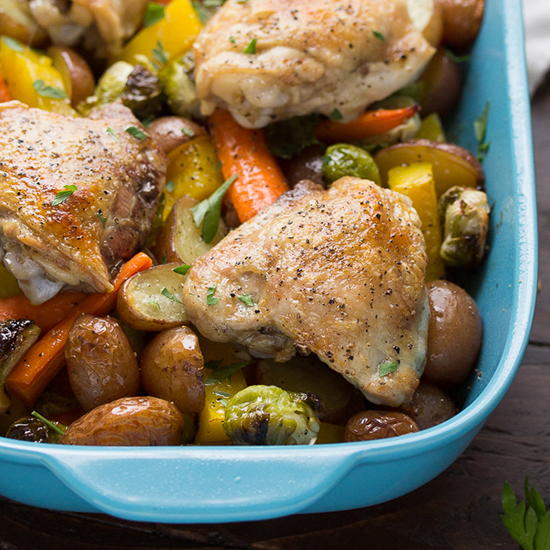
{"left": 195, "top": 369, "right": 246, "bottom": 445}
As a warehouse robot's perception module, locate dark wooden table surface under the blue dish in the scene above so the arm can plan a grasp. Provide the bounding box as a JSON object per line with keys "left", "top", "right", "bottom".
{"left": 0, "top": 80, "right": 550, "bottom": 550}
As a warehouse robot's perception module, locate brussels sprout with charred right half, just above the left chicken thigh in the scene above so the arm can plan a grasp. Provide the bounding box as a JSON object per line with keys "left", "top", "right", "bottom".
{"left": 78, "top": 61, "right": 163, "bottom": 118}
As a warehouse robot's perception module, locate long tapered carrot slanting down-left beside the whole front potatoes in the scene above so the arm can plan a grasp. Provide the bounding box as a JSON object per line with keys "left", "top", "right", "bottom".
{"left": 6, "top": 252, "right": 153, "bottom": 407}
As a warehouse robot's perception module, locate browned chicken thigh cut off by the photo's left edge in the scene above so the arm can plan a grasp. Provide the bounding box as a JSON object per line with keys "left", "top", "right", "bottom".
{"left": 0, "top": 101, "right": 166, "bottom": 303}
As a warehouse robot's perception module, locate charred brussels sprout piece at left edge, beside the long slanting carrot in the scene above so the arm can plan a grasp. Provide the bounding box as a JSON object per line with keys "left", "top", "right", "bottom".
{"left": 0, "top": 319, "right": 40, "bottom": 413}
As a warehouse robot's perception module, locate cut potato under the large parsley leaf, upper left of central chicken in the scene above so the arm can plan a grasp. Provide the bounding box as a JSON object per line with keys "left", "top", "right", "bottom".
{"left": 154, "top": 195, "right": 227, "bottom": 265}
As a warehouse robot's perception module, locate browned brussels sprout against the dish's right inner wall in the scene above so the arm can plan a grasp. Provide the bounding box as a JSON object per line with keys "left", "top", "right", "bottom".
{"left": 439, "top": 186, "right": 490, "bottom": 267}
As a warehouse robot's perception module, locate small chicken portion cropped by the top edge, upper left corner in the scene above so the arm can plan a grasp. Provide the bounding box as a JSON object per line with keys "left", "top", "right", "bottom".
{"left": 29, "top": 0, "right": 147, "bottom": 57}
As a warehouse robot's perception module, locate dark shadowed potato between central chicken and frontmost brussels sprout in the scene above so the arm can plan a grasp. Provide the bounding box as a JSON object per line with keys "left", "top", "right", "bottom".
{"left": 255, "top": 356, "right": 365, "bottom": 424}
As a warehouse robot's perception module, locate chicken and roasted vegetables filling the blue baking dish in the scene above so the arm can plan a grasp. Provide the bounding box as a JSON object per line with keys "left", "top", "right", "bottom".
{"left": 0, "top": 0, "right": 490, "bottom": 446}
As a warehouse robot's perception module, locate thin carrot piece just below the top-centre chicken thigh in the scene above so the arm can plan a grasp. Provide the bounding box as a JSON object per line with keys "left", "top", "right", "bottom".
{"left": 315, "top": 105, "right": 418, "bottom": 143}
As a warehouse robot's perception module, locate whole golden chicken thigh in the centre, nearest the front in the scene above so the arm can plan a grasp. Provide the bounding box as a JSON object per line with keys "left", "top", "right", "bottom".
{"left": 183, "top": 178, "right": 429, "bottom": 406}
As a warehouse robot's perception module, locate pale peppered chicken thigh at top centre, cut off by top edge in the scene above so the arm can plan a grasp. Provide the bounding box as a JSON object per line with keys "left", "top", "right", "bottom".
{"left": 194, "top": 0, "right": 434, "bottom": 128}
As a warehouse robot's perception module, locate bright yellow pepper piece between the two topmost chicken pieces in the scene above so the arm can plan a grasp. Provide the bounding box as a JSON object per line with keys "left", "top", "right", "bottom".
{"left": 117, "top": 0, "right": 202, "bottom": 65}
